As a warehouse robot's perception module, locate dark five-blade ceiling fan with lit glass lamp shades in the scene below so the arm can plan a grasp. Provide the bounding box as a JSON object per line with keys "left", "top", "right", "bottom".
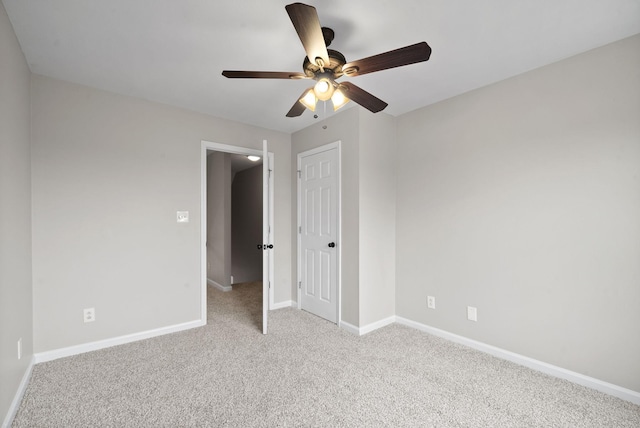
{"left": 222, "top": 3, "right": 431, "bottom": 117}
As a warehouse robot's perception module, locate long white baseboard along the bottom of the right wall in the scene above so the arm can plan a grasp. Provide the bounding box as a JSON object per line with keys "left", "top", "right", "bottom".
{"left": 396, "top": 317, "right": 640, "bottom": 404}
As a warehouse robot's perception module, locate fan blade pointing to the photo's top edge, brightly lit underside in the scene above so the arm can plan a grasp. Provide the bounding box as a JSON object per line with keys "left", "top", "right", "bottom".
{"left": 285, "top": 3, "right": 330, "bottom": 65}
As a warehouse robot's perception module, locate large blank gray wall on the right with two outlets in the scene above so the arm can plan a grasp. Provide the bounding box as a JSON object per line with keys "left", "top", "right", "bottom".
{"left": 396, "top": 36, "right": 640, "bottom": 391}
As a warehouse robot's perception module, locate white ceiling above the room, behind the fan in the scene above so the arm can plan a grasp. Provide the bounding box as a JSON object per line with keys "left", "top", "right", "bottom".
{"left": 3, "top": 0, "right": 640, "bottom": 132}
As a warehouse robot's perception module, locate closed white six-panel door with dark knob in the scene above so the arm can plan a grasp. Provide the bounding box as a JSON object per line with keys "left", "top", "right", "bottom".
{"left": 298, "top": 143, "right": 340, "bottom": 322}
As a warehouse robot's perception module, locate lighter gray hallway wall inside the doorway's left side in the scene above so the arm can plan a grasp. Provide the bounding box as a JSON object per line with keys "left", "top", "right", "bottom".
{"left": 207, "top": 152, "right": 231, "bottom": 287}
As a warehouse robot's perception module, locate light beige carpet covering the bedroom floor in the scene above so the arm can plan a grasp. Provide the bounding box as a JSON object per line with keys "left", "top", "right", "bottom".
{"left": 13, "top": 283, "right": 640, "bottom": 428}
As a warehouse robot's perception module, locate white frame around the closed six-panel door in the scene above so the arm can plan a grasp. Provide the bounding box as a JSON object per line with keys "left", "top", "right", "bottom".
{"left": 296, "top": 140, "right": 342, "bottom": 327}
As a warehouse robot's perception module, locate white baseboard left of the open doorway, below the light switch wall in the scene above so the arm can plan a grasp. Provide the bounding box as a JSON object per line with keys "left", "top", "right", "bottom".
{"left": 34, "top": 320, "right": 206, "bottom": 363}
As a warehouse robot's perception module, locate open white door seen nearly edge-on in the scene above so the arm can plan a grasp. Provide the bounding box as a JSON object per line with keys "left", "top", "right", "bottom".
{"left": 262, "top": 140, "right": 273, "bottom": 334}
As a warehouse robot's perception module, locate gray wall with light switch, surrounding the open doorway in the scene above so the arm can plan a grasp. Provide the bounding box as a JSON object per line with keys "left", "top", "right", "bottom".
{"left": 32, "top": 76, "right": 291, "bottom": 352}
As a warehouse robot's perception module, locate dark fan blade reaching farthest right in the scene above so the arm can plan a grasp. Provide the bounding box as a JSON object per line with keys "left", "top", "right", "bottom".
{"left": 342, "top": 42, "right": 431, "bottom": 76}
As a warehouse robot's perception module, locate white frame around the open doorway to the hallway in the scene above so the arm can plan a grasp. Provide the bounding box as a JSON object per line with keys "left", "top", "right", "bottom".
{"left": 200, "top": 140, "right": 275, "bottom": 324}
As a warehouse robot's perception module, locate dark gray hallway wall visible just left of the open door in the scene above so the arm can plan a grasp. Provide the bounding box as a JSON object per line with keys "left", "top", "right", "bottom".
{"left": 231, "top": 165, "right": 262, "bottom": 284}
